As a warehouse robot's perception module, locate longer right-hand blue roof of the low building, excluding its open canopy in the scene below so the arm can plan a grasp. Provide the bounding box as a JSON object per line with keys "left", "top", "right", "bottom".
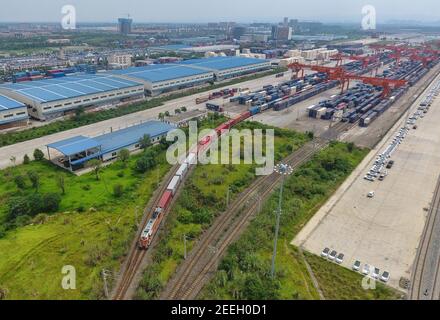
{"left": 94, "top": 121, "right": 176, "bottom": 154}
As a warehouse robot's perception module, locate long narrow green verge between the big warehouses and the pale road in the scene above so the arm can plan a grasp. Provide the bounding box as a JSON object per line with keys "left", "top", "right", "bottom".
{"left": 0, "top": 69, "right": 281, "bottom": 147}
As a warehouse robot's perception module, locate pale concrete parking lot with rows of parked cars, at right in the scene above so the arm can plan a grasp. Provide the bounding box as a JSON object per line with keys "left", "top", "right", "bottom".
{"left": 293, "top": 72, "right": 440, "bottom": 288}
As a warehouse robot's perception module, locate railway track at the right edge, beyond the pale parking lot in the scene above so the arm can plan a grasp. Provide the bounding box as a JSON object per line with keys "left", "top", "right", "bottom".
{"left": 409, "top": 177, "right": 440, "bottom": 300}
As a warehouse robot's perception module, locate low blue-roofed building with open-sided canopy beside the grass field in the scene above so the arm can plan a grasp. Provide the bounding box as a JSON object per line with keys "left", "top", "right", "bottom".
{"left": 46, "top": 121, "right": 176, "bottom": 171}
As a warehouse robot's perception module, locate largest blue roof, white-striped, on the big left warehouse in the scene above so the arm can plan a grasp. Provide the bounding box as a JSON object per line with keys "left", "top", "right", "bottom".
{"left": 0, "top": 74, "right": 140, "bottom": 102}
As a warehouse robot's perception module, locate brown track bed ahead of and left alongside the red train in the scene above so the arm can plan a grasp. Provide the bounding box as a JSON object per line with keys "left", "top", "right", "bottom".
{"left": 112, "top": 165, "right": 179, "bottom": 300}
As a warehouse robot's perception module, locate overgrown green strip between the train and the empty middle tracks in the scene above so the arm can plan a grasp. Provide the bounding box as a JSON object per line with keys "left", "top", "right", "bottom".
{"left": 137, "top": 122, "right": 308, "bottom": 299}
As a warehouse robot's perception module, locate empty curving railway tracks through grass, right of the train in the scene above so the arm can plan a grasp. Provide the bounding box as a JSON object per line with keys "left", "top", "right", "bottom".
{"left": 161, "top": 139, "right": 334, "bottom": 300}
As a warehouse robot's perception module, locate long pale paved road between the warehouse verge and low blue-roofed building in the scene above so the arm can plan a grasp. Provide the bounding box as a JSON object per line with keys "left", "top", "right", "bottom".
{"left": 0, "top": 72, "right": 298, "bottom": 169}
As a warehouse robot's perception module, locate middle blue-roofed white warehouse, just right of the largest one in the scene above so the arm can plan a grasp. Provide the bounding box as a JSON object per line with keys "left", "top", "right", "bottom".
{"left": 111, "top": 63, "right": 214, "bottom": 96}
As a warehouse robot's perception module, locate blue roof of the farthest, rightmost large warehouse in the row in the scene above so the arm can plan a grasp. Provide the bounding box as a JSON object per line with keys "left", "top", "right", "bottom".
{"left": 179, "top": 57, "right": 269, "bottom": 70}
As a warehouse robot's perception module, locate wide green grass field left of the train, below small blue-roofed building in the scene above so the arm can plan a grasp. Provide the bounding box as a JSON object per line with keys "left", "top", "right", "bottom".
{"left": 0, "top": 144, "right": 170, "bottom": 299}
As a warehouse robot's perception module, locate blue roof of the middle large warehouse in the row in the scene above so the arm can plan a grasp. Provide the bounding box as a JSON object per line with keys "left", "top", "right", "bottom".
{"left": 111, "top": 63, "right": 210, "bottom": 82}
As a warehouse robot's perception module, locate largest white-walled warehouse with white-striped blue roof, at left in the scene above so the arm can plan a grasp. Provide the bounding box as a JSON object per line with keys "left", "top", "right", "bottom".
{"left": 0, "top": 74, "right": 144, "bottom": 120}
